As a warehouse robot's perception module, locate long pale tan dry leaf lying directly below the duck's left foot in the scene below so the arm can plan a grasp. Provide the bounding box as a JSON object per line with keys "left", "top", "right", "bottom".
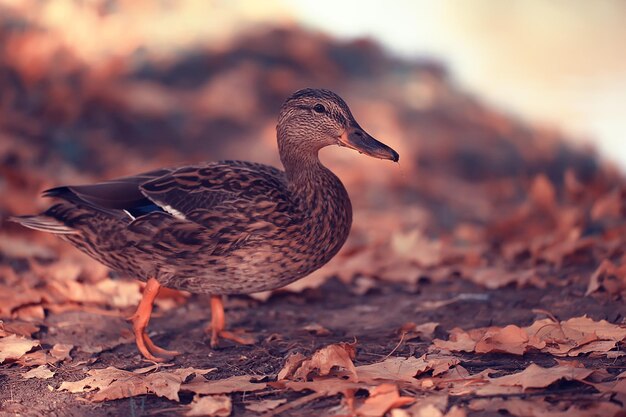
{"left": 59, "top": 366, "right": 211, "bottom": 402}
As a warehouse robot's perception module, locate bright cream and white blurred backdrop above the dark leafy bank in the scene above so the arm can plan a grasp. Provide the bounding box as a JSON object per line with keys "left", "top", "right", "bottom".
{"left": 0, "top": 0, "right": 626, "bottom": 166}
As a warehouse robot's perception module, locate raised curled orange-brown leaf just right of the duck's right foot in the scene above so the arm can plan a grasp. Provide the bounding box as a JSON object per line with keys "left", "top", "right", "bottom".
{"left": 278, "top": 343, "right": 357, "bottom": 381}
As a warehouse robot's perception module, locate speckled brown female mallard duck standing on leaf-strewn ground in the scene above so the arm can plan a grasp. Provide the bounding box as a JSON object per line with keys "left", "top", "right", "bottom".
{"left": 14, "top": 89, "right": 399, "bottom": 361}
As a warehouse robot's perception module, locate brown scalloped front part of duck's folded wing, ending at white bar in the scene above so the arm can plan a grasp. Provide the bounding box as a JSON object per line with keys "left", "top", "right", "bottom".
{"left": 139, "top": 161, "right": 291, "bottom": 227}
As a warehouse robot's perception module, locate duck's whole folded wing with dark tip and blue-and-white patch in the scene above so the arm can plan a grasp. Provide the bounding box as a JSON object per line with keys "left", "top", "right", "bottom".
{"left": 27, "top": 161, "right": 292, "bottom": 233}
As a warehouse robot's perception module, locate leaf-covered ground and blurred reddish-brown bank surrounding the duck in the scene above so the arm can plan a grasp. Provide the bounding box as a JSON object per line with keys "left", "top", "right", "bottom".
{"left": 0, "top": 12, "right": 626, "bottom": 417}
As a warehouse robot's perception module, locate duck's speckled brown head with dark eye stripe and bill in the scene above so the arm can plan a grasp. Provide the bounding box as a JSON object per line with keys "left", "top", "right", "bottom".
{"left": 277, "top": 88, "right": 400, "bottom": 162}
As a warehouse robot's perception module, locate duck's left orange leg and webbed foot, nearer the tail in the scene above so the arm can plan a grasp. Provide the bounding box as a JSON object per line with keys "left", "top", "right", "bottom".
{"left": 128, "top": 278, "right": 178, "bottom": 362}
